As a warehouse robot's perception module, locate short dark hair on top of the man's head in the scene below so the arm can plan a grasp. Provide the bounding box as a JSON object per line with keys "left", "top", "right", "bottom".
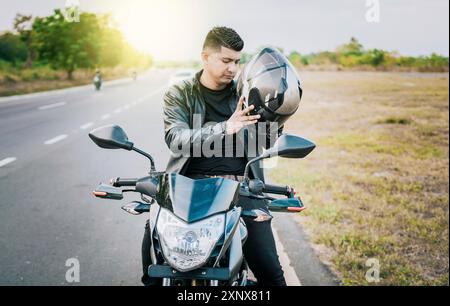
{"left": 203, "top": 27, "right": 244, "bottom": 51}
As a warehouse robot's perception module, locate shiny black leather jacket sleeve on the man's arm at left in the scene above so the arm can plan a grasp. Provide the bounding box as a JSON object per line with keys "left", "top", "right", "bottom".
{"left": 163, "top": 85, "right": 226, "bottom": 154}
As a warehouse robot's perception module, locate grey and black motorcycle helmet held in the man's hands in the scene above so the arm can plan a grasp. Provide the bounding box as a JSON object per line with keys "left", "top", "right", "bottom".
{"left": 236, "top": 48, "right": 302, "bottom": 126}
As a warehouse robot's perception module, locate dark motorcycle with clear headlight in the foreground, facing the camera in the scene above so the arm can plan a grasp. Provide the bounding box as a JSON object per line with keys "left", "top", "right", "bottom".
{"left": 89, "top": 125, "right": 315, "bottom": 286}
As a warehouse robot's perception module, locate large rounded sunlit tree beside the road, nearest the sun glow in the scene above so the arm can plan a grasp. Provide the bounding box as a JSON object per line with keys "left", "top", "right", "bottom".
{"left": 33, "top": 10, "right": 151, "bottom": 79}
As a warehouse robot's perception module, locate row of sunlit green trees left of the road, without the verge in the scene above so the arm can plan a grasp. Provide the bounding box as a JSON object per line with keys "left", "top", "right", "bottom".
{"left": 0, "top": 9, "right": 152, "bottom": 79}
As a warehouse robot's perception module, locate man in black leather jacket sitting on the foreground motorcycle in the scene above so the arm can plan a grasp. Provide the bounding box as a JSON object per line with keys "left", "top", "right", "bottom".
{"left": 142, "top": 27, "right": 286, "bottom": 286}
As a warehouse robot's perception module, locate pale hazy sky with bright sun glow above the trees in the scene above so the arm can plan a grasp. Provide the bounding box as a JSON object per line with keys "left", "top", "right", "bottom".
{"left": 0, "top": 0, "right": 449, "bottom": 60}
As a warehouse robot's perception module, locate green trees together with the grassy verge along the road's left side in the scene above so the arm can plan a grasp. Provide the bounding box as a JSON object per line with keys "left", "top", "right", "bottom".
{"left": 0, "top": 10, "right": 153, "bottom": 96}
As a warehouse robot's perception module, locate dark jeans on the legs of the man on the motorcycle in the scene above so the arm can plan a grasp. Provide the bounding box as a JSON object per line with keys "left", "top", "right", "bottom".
{"left": 142, "top": 197, "right": 286, "bottom": 286}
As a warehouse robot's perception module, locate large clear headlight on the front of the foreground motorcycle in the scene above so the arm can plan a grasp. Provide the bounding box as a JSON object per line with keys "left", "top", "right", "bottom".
{"left": 156, "top": 209, "right": 225, "bottom": 272}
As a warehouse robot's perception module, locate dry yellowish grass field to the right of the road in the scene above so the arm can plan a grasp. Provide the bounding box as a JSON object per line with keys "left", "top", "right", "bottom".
{"left": 269, "top": 72, "right": 449, "bottom": 285}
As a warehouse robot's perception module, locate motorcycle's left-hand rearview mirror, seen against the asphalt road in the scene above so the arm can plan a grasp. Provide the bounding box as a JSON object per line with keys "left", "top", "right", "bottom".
{"left": 89, "top": 125, "right": 133, "bottom": 151}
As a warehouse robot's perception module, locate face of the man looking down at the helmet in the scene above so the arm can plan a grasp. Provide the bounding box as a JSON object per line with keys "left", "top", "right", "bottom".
{"left": 202, "top": 47, "right": 241, "bottom": 85}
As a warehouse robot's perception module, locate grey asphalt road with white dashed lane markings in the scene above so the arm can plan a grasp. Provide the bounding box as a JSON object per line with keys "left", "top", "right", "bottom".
{"left": 0, "top": 70, "right": 336, "bottom": 285}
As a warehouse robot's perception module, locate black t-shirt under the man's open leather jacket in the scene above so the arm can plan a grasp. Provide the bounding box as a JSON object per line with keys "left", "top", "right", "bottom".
{"left": 186, "top": 79, "right": 247, "bottom": 175}
